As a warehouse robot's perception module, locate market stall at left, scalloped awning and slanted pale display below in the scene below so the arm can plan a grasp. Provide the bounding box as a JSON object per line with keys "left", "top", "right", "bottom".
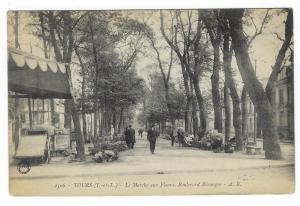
{"left": 8, "top": 48, "right": 72, "bottom": 162}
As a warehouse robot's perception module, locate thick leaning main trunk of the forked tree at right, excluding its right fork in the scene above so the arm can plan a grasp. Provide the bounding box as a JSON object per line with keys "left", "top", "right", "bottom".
{"left": 226, "top": 9, "right": 281, "bottom": 159}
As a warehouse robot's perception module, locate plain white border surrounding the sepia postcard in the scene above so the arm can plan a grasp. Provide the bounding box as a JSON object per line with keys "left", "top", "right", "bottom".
{"left": 0, "top": 0, "right": 300, "bottom": 206}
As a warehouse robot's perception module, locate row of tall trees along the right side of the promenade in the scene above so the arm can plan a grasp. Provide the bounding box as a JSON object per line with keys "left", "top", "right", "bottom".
{"left": 137, "top": 9, "right": 293, "bottom": 159}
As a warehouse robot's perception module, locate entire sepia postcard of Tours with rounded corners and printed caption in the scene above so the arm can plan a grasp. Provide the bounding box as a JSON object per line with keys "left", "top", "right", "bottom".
{"left": 4, "top": 8, "right": 295, "bottom": 196}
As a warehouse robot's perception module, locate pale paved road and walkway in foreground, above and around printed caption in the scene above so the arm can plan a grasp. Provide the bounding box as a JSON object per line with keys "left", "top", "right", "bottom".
{"left": 10, "top": 135, "right": 294, "bottom": 195}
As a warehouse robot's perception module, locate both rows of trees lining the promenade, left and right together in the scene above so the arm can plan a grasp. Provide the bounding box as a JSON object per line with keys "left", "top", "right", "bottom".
{"left": 9, "top": 9, "right": 293, "bottom": 160}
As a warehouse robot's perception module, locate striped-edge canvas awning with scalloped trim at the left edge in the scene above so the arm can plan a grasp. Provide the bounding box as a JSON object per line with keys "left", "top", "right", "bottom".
{"left": 8, "top": 48, "right": 71, "bottom": 99}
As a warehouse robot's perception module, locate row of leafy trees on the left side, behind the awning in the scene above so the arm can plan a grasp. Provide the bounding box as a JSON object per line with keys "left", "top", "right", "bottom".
{"left": 10, "top": 11, "right": 149, "bottom": 160}
